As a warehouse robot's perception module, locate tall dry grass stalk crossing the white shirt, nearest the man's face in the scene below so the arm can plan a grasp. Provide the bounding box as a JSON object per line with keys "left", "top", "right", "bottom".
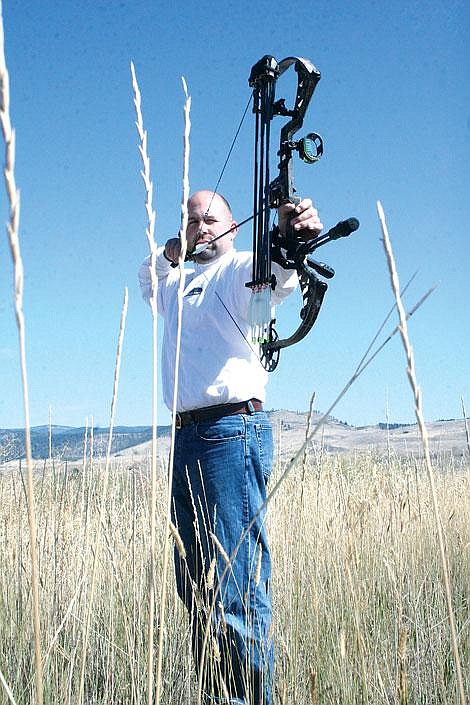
{"left": 155, "top": 77, "right": 191, "bottom": 705}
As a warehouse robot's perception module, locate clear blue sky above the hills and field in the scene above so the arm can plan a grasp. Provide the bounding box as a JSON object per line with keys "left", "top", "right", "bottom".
{"left": 0, "top": 0, "right": 470, "bottom": 427}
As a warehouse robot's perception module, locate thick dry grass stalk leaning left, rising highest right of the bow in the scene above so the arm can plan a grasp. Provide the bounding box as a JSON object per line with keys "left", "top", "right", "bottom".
{"left": 377, "top": 201, "right": 467, "bottom": 705}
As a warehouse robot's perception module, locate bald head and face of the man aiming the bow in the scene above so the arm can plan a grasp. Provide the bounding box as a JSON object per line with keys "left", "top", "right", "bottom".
{"left": 186, "top": 191, "right": 237, "bottom": 264}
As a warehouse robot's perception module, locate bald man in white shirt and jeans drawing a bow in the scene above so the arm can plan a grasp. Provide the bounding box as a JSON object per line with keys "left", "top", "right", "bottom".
{"left": 139, "top": 191, "right": 323, "bottom": 705}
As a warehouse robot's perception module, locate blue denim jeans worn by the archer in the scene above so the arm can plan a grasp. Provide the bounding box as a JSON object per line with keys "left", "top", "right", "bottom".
{"left": 172, "top": 412, "right": 274, "bottom": 705}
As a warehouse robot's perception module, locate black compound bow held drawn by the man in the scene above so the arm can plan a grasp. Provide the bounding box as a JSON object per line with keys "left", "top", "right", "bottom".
{"left": 246, "top": 55, "right": 359, "bottom": 371}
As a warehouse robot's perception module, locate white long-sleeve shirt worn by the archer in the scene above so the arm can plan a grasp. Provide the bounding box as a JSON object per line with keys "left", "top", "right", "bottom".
{"left": 139, "top": 247, "right": 298, "bottom": 411}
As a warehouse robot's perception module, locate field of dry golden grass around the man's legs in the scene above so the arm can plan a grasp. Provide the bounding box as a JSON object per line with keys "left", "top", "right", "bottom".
{"left": 0, "top": 448, "right": 470, "bottom": 705}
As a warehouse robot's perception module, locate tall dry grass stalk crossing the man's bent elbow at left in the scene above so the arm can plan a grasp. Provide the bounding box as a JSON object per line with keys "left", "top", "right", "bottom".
{"left": 131, "top": 62, "right": 158, "bottom": 705}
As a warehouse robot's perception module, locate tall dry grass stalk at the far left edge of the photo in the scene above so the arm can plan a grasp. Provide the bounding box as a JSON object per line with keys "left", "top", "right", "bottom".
{"left": 0, "top": 9, "right": 43, "bottom": 705}
